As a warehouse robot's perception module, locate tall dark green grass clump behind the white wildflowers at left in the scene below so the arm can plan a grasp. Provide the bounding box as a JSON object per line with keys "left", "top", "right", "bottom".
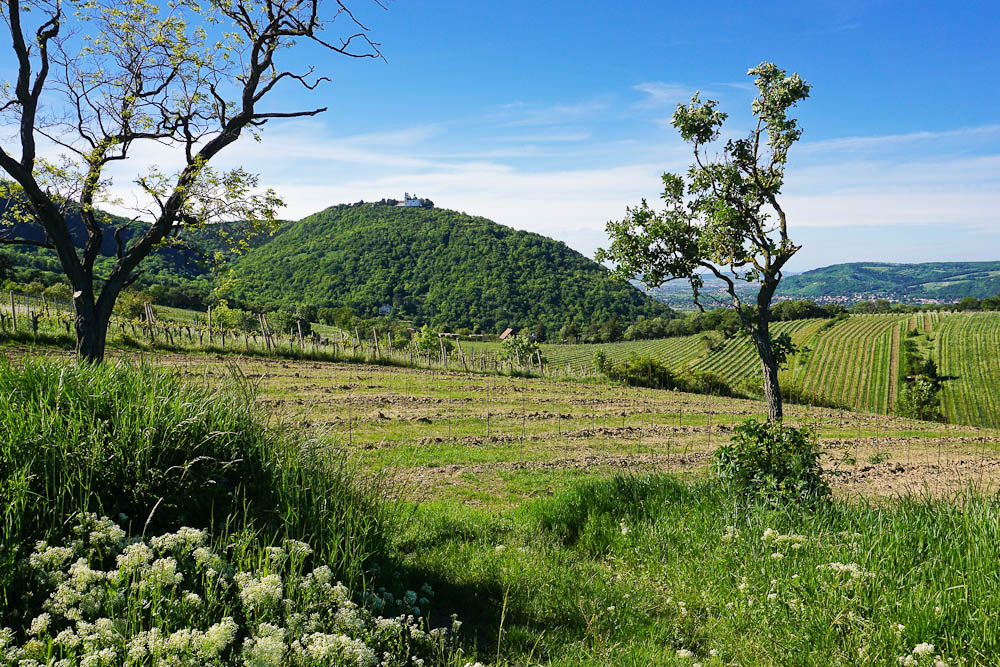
{"left": 0, "top": 360, "right": 390, "bottom": 623}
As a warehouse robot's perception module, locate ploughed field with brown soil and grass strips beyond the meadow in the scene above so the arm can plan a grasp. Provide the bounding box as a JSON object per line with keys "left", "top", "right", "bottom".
{"left": 119, "top": 355, "right": 1000, "bottom": 505}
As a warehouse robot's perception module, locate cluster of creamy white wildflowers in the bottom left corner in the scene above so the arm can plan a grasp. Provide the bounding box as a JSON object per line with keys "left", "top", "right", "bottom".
{"left": 0, "top": 514, "right": 461, "bottom": 667}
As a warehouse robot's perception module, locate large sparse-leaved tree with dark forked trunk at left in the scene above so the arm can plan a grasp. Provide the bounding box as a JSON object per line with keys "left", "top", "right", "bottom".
{"left": 0, "top": 0, "right": 380, "bottom": 362}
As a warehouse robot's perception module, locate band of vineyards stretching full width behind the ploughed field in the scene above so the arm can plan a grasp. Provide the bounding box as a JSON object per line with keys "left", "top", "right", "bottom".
{"left": 7, "top": 298, "right": 1000, "bottom": 428}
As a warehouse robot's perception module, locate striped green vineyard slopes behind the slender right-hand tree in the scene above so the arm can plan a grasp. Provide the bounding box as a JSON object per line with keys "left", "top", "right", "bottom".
{"left": 469, "top": 312, "right": 1000, "bottom": 427}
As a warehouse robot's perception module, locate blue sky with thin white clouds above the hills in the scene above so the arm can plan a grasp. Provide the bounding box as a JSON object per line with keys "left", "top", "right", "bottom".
{"left": 11, "top": 0, "right": 1000, "bottom": 270}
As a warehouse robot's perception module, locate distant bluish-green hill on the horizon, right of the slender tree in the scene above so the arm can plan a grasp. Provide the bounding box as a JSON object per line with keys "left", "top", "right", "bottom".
{"left": 780, "top": 262, "right": 1000, "bottom": 299}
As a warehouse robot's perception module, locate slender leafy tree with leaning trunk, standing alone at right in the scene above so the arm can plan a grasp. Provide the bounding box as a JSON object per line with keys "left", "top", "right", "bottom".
{"left": 598, "top": 63, "right": 810, "bottom": 421}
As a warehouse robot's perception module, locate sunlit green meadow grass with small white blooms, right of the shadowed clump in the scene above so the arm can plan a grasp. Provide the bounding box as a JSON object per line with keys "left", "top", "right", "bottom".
{"left": 397, "top": 476, "right": 1000, "bottom": 665}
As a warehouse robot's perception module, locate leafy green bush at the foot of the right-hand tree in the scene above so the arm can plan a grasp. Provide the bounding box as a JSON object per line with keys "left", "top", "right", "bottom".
{"left": 712, "top": 418, "right": 830, "bottom": 504}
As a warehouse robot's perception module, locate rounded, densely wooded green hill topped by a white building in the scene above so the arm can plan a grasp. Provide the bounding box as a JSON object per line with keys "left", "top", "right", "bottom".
{"left": 228, "top": 205, "right": 668, "bottom": 331}
